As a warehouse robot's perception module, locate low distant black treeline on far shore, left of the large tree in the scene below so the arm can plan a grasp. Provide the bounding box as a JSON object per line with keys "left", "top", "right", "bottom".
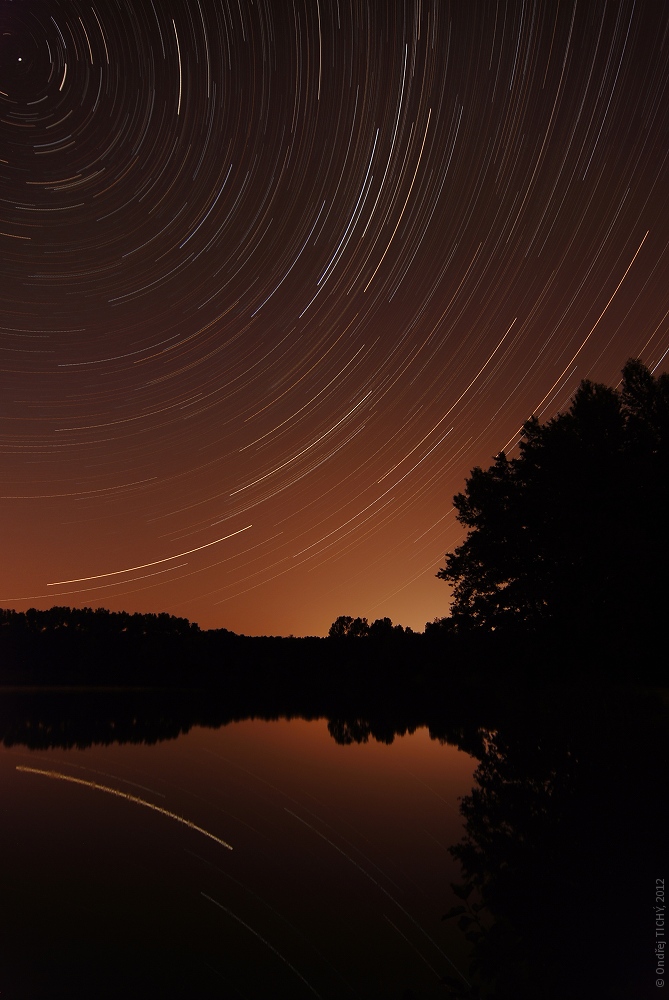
{"left": 0, "top": 607, "right": 424, "bottom": 687}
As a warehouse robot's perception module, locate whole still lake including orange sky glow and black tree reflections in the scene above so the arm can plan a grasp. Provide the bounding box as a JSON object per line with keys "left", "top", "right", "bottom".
{"left": 0, "top": 687, "right": 667, "bottom": 1000}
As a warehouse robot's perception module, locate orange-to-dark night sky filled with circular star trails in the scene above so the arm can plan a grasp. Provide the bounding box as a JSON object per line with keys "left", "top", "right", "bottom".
{"left": 0, "top": 0, "right": 669, "bottom": 635}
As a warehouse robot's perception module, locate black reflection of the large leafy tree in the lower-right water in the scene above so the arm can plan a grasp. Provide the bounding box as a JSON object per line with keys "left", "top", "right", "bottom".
{"left": 446, "top": 690, "right": 666, "bottom": 1000}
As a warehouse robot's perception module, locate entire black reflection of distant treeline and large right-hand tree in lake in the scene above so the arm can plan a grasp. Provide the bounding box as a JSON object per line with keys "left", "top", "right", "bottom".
{"left": 0, "top": 681, "right": 668, "bottom": 1000}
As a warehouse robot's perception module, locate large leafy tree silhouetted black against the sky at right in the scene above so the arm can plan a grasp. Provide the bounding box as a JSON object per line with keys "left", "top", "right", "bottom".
{"left": 437, "top": 360, "right": 669, "bottom": 632}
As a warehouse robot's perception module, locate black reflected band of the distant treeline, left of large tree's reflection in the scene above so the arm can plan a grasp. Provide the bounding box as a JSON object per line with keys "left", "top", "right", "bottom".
{"left": 0, "top": 661, "right": 487, "bottom": 749}
